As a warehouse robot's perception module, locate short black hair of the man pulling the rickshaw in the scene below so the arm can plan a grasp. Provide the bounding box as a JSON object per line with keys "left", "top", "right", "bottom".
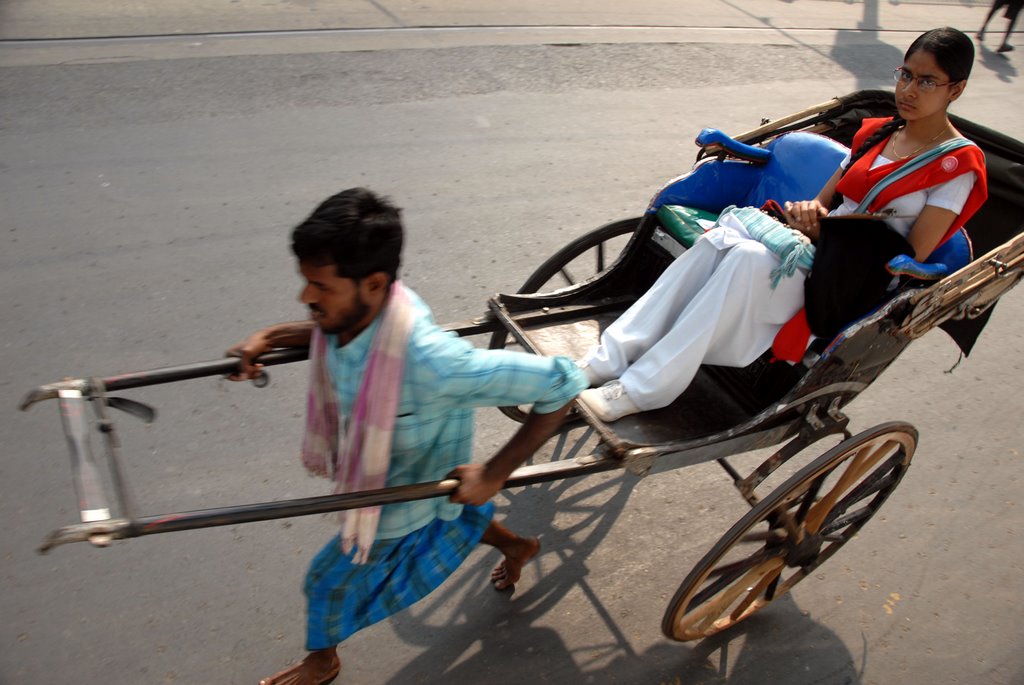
{"left": 292, "top": 188, "right": 402, "bottom": 281}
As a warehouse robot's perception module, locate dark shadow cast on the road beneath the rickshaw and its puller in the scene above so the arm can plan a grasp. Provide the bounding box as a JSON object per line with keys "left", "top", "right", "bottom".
{"left": 374, "top": 423, "right": 860, "bottom": 685}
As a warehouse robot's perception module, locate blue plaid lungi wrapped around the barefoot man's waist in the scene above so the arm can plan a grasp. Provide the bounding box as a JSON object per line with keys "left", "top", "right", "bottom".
{"left": 304, "top": 502, "right": 495, "bottom": 651}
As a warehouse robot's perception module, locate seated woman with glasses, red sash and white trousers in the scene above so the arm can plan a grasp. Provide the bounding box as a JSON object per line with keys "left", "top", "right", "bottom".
{"left": 578, "top": 28, "right": 987, "bottom": 421}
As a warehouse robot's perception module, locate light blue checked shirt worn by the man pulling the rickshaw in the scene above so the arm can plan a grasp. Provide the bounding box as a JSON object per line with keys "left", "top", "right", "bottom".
{"left": 327, "top": 289, "right": 587, "bottom": 540}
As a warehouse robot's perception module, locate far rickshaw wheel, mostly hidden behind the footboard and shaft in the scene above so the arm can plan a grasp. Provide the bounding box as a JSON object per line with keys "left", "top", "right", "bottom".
{"left": 488, "top": 216, "right": 641, "bottom": 423}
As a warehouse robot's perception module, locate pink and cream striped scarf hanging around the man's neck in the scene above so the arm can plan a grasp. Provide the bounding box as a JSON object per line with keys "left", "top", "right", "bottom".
{"left": 302, "top": 281, "right": 414, "bottom": 564}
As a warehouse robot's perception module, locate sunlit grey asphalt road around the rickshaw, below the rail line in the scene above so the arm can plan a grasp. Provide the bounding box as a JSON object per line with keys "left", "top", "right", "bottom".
{"left": 0, "top": 10, "right": 1024, "bottom": 685}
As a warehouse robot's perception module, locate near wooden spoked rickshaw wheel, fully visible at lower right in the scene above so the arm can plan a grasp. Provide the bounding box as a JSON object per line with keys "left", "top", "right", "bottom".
{"left": 662, "top": 422, "right": 918, "bottom": 642}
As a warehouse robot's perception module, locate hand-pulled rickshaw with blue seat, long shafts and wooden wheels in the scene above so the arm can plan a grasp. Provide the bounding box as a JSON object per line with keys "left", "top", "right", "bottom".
{"left": 22, "top": 91, "right": 1024, "bottom": 641}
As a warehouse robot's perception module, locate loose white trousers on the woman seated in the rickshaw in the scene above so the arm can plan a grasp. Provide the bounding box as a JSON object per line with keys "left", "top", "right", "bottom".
{"left": 584, "top": 226, "right": 807, "bottom": 411}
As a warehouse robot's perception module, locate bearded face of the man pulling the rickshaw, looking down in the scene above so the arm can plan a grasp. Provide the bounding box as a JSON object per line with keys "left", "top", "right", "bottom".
{"left": 299, "top": 262, "right": 373, "bottom": 336}
